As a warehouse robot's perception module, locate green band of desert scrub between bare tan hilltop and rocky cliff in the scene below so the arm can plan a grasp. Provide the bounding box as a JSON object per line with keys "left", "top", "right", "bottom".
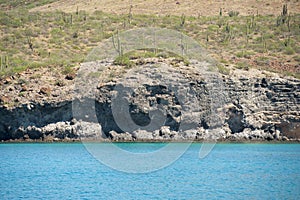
{"left": 0, "top": 0, "right": 300, "bottom": 78}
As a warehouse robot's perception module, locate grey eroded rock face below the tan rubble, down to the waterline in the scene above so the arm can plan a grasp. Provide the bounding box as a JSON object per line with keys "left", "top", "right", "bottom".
{"left": 0, "top": 60, "right": 300, "bottom": 141}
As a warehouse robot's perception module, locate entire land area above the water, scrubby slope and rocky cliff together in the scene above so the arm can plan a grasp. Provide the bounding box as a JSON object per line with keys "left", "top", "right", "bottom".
{"left": 0, "top": 0, "right": 300, "bottom": 141}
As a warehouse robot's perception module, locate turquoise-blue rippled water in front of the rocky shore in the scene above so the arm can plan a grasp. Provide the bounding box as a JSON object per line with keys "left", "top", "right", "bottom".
{"left": 0, "top": 143, "right": 300, "bottom": 199}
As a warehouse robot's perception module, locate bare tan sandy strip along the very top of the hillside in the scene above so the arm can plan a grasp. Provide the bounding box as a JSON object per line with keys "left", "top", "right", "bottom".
{"left": 31, "top": 0, "right": 300, "bottom": 16}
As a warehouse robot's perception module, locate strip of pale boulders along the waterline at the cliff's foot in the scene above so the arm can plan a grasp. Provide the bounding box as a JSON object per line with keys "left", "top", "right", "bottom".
{"left": 1, "top": 120, "right": 300, "bottom": 143}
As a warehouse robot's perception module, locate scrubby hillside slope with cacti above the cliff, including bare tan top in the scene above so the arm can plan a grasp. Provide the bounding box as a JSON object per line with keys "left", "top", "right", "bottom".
{"left": 0, "top": 0, "right": 300, "bottom": 77}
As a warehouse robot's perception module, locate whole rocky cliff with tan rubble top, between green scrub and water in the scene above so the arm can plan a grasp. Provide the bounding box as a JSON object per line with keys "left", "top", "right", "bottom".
{"left": 0, "top": 59, "right": 300, "bottom": 141}
